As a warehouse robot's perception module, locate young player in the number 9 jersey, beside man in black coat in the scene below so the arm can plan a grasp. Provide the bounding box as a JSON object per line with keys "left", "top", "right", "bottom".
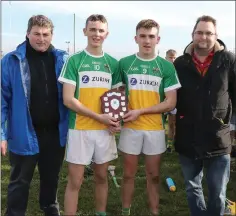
{"left": 118, "top": 19, "right": 180, "bottom": 215}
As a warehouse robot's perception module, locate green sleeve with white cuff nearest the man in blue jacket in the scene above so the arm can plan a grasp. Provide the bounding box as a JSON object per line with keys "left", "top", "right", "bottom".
{"left": 58, "top": 56, "right": 78, "bottom": 86}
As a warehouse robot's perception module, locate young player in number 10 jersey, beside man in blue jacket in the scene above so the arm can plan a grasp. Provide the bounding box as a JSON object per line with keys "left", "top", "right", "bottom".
{"left": 59, "top": 15, "right": 122, "bottom": 216}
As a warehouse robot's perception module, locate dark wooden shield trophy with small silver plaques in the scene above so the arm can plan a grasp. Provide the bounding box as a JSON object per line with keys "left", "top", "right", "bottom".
{"left": 101, "top": 89, "right": 128, "bottom": 120}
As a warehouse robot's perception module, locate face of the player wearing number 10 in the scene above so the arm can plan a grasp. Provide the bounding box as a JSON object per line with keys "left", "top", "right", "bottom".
{"left": 83, "top": 21, "right": 108, "bottom": 48}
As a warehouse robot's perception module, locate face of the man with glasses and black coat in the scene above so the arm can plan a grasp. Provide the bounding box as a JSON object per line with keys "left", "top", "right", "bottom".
{"left": 192, "top": 21, "right": 217, "bottom": 50}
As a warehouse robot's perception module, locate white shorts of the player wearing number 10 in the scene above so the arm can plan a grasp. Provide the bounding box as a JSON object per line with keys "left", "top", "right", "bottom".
{"left": 65, "top": 129, "right": 118, "bottom": 165}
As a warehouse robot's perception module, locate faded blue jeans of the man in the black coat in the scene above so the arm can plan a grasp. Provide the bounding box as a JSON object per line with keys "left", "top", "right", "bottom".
{"left": 179, "top": 154, "right": 230, "bottom": 216}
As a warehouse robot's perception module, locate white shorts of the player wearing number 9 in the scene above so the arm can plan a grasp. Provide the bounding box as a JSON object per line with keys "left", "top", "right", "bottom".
{"left": 118, "top": 128, "right": 166, "bottom": 155}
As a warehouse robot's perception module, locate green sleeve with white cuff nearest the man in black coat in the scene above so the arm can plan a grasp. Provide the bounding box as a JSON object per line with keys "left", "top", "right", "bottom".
{"left": 163, "top": 63, "right": 181, "bottom": 92}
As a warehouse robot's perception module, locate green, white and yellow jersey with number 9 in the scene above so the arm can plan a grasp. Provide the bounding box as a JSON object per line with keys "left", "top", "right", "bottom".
{"left": 119, "top": 54, "right": 181, "bottom": 130}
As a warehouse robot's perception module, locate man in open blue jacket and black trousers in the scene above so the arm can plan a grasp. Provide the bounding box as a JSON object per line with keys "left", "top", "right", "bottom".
{"left": 1, "top": 15, "right": 68, "bottom": 216}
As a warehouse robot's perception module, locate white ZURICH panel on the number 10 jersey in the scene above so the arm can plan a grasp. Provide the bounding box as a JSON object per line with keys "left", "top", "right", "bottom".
{"left": 79, "top": 71, "right": 112, "bottom": 89}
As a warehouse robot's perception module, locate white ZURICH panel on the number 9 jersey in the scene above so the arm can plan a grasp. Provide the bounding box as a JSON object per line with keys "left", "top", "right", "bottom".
{"left": 128, "top": 74, "right": 162, "bottom": 93}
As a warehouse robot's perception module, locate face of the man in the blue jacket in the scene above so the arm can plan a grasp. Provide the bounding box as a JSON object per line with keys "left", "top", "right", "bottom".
{"left": 27, "top": 25, "right": 52, "bottom": 52}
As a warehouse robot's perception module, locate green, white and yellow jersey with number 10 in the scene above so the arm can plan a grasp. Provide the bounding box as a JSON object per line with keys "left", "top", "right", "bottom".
{"left": 59, "top": 50, "right": 122, "bottom": 130}
